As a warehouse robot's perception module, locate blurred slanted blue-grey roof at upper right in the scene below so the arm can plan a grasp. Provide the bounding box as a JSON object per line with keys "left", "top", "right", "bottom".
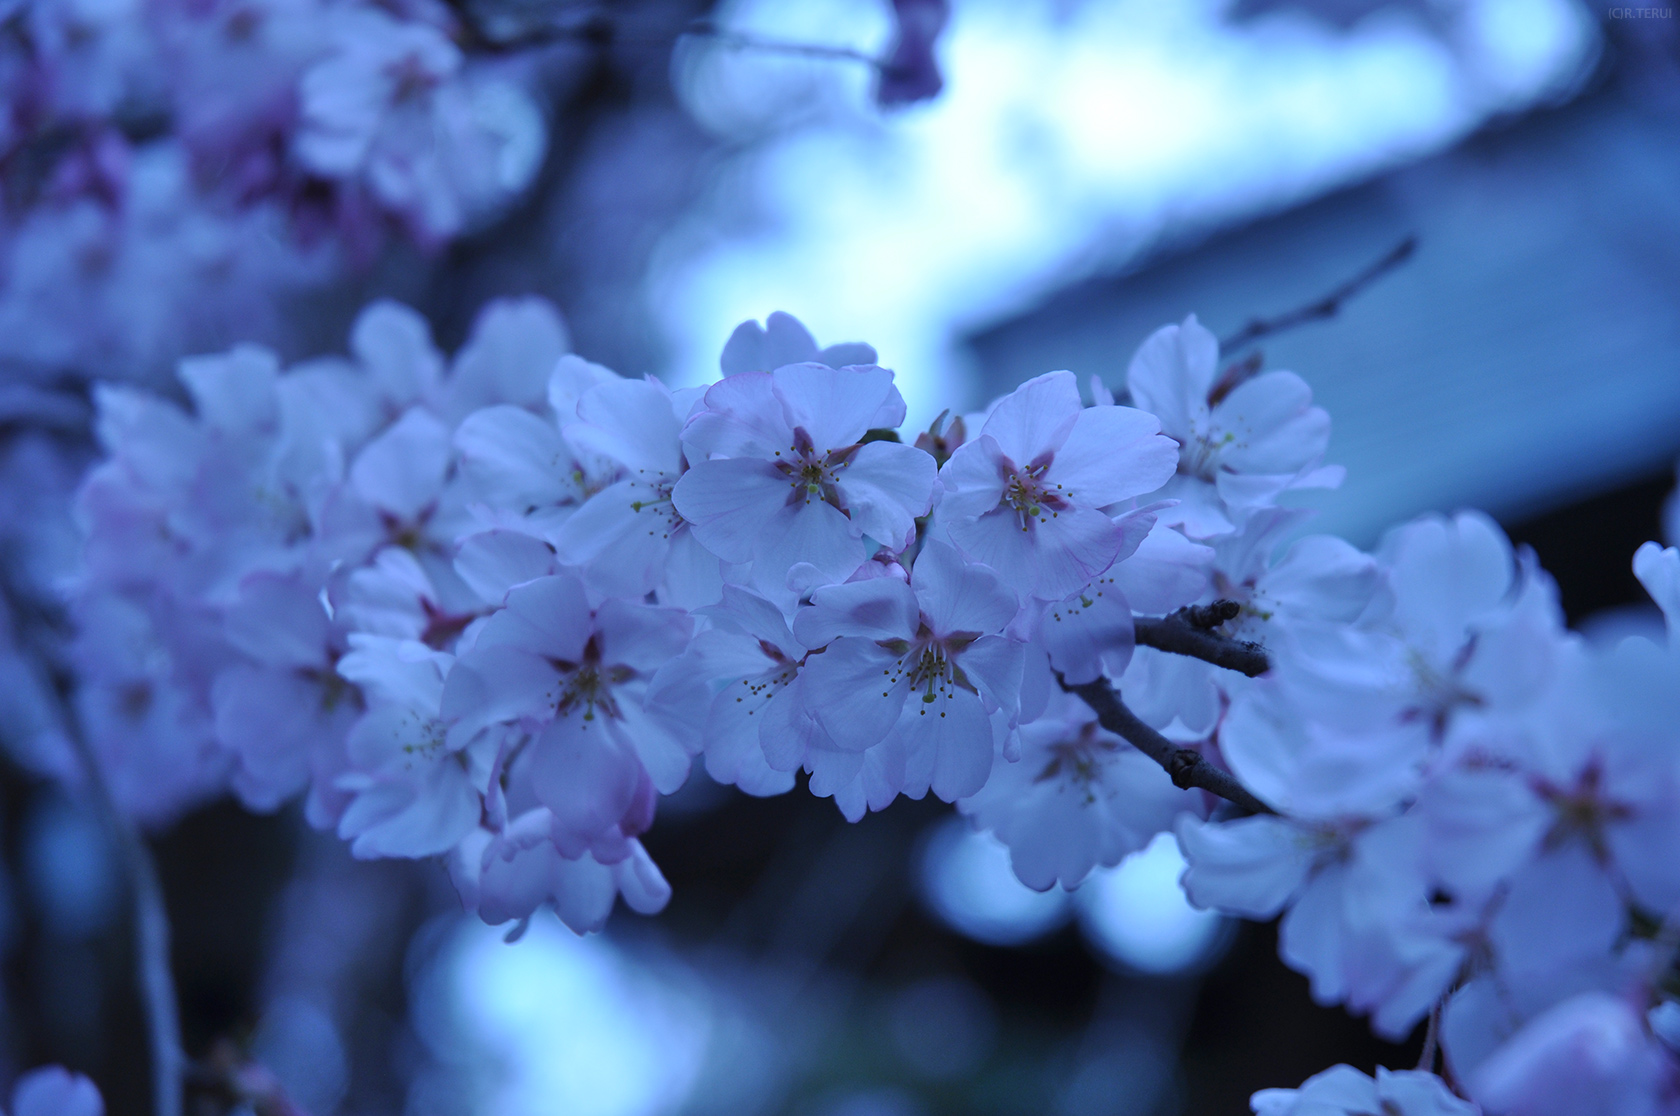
{"left": 969, "top": 79, "right": 1680, "bottom": 543}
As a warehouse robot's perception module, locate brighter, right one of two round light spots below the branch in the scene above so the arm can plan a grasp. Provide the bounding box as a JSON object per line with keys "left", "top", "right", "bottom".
{"left": 1074, "top": 834, "right": 1230, "bottom": 977}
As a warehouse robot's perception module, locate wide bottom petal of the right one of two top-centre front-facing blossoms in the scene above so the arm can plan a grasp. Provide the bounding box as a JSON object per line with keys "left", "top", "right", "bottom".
{"left": 951, "top": 508, "right": 1124, "bottom": 600}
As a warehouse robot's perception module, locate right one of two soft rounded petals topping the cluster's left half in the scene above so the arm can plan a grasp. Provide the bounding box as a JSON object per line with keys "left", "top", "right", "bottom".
{"left": 449, "top": 297, "right": 571, "bottom": 415}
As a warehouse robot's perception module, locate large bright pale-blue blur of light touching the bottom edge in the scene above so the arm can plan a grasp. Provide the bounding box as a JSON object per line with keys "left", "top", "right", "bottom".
{"left": 415, "top": 919, "right": 712, "bottom": 1116}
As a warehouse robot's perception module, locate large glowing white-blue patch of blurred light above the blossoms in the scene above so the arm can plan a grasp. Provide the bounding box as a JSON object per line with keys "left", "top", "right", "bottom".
{"left": 652, "top": 0, "right": 1596, "bottom": 427}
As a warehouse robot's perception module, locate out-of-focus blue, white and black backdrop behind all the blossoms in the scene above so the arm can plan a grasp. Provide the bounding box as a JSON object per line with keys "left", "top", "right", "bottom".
{"left": 0, "top": 0, "right": 1680, "bottom": 1116}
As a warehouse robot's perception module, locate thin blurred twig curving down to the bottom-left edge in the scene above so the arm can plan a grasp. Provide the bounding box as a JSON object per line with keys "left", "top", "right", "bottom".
{"left": 0, "top": 576, "right": 186, "bottom": 1116}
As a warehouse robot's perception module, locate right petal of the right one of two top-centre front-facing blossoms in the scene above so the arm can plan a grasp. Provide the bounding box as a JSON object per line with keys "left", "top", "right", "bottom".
{"left": 1045, "top": 407, "right": 1178, "bottom": 508}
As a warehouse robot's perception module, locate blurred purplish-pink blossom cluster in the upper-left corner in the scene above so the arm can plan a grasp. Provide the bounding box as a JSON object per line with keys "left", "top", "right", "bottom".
{"left": 0, "top": 0, "right": 546, "bottom": 376}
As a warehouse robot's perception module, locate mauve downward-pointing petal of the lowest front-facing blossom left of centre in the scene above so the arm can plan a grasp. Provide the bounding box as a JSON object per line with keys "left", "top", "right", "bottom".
{"left": 529, "top": 711, "right": 642, "bottom": 855}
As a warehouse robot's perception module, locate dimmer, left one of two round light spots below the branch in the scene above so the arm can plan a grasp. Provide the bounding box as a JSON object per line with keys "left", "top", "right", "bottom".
{"left": 921, "top": 819, "right": 1070, "bottom": 946}
